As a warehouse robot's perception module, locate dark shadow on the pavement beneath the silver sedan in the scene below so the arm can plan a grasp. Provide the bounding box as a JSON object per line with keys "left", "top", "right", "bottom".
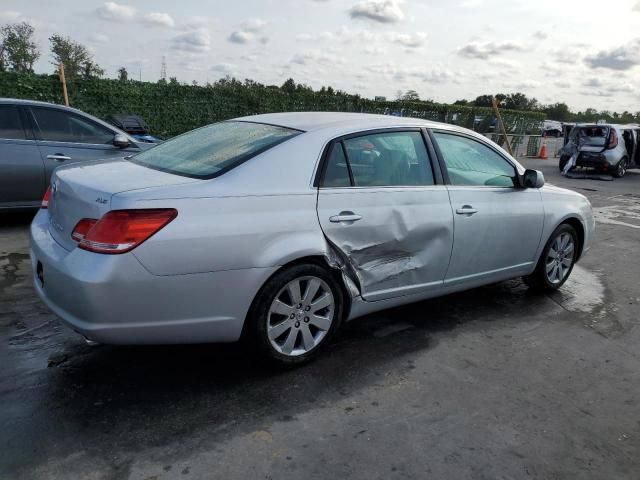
{"left": 18, "top": 281, "right": 548, "bottom": 464}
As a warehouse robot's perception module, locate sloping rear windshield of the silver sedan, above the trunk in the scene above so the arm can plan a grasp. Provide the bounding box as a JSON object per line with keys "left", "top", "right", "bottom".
{"left": 130, "top": 121, "right": 301, "bottom": 178}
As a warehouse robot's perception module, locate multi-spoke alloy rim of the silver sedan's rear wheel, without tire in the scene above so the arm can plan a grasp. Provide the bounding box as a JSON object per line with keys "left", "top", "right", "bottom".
{"left": 267, "top": 276, "right": 335, "bottom": 356}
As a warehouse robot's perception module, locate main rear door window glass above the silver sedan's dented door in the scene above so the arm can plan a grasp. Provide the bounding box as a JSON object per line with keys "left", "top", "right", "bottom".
{"left": 336, "top": 132, "right": 434, "bottom": 187}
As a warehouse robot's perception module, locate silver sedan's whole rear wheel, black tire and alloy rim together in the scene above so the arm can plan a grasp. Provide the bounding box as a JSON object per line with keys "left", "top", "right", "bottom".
{"left": 250, "top": 264, "right": 344, "bottom": 365}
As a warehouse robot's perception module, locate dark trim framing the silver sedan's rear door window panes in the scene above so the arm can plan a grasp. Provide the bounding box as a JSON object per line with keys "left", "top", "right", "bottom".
{"left": 313, "top": 127, "right": 444, "bottom": 189}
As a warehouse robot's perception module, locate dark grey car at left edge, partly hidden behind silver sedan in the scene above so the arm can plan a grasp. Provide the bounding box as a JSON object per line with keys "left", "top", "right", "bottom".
{"left": 0, "top": 98, "right": 153, "bottom": 210}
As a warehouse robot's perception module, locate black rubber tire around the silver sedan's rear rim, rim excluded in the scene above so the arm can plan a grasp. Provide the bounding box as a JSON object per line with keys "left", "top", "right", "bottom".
{"left": 247, "top": 263, "right": 344, "bottom": 365}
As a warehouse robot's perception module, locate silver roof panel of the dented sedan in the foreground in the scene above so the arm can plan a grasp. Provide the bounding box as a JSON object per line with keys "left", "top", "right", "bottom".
{"left": 233, "top": 112, "right": 452, "bottom": 132}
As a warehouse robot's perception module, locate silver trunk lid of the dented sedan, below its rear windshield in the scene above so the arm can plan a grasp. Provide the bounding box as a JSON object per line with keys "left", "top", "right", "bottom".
{"left": 48, "top": 160, "right": 199, "bottom": 250}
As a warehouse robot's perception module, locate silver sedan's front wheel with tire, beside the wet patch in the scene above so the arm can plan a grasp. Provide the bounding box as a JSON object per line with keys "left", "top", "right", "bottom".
{"left": 523, "top": 223, "right": 578, "bottom": 292}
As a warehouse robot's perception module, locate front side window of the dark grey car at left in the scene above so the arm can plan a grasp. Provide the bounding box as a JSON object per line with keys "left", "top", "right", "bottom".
{"left": 31, "top": 107, "right": 114, "bottom": 145}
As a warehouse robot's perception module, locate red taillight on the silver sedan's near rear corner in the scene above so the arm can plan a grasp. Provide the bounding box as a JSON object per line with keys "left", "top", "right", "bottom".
{"left": 74, "top": 208, "right": 178, "bottom": 253}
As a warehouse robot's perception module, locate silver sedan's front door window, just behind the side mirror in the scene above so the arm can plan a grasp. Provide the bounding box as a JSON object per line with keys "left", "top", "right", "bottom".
{"left": 434, "top": 132, "right": 517, "bottom": 187}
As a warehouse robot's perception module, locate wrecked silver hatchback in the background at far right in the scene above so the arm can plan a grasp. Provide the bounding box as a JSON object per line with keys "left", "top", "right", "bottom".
{"left": 558, "top": 124, "right": 640, "bottom": 178}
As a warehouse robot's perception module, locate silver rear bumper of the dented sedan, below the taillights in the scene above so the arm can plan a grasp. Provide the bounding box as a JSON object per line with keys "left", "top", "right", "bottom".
{"left": 31, "top": 210, "right": 276, "bottom": 344}
